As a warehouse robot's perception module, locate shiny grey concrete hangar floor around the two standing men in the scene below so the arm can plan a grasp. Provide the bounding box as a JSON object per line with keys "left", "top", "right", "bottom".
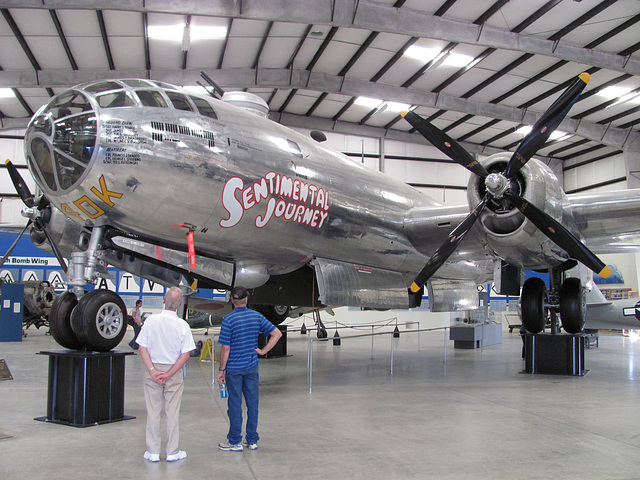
{"left": 0, "top": 318, "right": 640, "bottom": 480}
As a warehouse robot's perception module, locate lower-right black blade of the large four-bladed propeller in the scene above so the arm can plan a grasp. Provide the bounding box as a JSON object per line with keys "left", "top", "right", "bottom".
{"left": 504, "top": 191, "right": 611, "bottom": 278}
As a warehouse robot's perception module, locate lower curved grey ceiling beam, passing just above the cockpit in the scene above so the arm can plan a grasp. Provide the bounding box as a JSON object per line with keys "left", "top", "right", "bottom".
{"left": 0, "top": 68, "right": 640, "bottom": 151}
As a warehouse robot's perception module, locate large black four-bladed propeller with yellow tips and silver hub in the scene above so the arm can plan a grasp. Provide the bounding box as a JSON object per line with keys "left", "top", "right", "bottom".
{"left": 401, "top": 72, "right": 611, "bottom": 293}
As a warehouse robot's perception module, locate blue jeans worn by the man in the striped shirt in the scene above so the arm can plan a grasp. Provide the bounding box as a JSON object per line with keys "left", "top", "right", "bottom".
{"left": 225, "top": 365, "right": 260, "bottom": 445}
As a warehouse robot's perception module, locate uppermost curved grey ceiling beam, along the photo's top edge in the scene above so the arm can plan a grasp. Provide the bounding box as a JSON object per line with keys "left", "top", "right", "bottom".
{"left": 5, "top": 0, "right": 640, "bottom": 75}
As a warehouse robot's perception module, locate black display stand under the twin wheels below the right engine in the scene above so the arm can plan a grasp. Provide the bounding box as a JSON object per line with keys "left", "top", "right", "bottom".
{"left": 522, "top": 333, "right": 589, "bottom": 376}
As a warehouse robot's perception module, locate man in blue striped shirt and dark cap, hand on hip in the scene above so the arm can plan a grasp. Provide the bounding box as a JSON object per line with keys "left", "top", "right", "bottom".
{"left": 217, "top": 286, "right": 282, "bottom": 452}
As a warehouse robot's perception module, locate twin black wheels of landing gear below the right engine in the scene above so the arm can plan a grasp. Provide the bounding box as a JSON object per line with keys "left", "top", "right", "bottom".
{"left": 520, "top": 269, "right": 587, "bottom": 334}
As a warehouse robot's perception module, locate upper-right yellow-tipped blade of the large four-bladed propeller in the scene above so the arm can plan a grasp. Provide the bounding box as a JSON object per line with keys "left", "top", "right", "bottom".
{"left": 504, "top": 72, "right": 591, "bottom": 178}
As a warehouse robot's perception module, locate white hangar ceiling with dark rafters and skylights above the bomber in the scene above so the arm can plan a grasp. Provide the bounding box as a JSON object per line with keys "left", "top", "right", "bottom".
{"left": 0, "top": 0, "right": 640, "bottom": 167}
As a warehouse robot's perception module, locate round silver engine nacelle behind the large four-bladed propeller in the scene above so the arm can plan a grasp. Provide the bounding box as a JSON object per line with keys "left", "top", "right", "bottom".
{"left": 467, "top": 153, "right": 579, "bottom": 270}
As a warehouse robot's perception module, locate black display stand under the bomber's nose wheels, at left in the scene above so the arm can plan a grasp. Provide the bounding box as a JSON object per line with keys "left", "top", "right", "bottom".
{"left": 35, "top": 350, "right": 135, "bottom": 427}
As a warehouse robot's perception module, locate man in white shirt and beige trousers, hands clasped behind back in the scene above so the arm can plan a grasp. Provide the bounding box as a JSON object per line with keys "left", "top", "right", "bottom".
{"left": 137, "top": 287, "right": 196, "bottom": 462}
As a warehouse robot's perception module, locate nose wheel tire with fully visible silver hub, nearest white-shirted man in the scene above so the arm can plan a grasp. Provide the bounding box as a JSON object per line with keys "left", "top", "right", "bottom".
{"left": 71, "top": 289, "right": 127, "bottom": 352}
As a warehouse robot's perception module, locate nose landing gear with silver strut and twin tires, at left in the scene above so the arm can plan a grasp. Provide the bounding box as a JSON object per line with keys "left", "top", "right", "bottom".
{"left": 49, "top": 227, "right": 127, "bottom": 352}
